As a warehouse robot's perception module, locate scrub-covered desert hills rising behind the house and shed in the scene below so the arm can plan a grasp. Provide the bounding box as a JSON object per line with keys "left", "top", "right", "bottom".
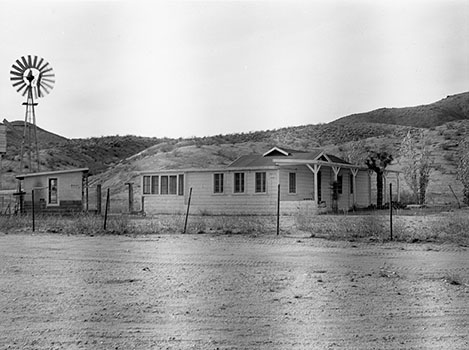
{"left": 2, "top": 92, "right": 469, "bottom": 209}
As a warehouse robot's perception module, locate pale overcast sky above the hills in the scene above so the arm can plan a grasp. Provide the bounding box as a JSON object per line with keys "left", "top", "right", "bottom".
{"left": 0, "top": 0, "right": 469, "bottom": 138}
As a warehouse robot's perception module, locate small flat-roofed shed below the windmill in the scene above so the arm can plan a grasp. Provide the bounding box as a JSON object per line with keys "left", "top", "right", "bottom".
{"left": 16, "top": 168, "right": 88, "bottom": 214}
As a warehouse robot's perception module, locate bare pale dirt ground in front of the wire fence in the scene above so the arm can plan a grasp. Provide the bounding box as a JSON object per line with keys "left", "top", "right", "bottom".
{"left": 0, "top": 233, "right": 469, "bottom": 350}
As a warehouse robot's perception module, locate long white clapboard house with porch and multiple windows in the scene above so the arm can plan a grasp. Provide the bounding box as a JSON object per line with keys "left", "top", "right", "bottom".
{"left": 141, "top": 147, "right": 371, "bottom": 215}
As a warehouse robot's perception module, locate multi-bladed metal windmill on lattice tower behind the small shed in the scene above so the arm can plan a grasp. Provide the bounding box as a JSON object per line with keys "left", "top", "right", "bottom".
{"left": 10, "top": 55, "right": 55, "bottom": 172}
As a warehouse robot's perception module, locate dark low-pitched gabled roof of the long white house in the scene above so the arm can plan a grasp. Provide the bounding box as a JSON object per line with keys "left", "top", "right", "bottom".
{"left": 228, "top": 147, "right": 349, "bottom": 168}
